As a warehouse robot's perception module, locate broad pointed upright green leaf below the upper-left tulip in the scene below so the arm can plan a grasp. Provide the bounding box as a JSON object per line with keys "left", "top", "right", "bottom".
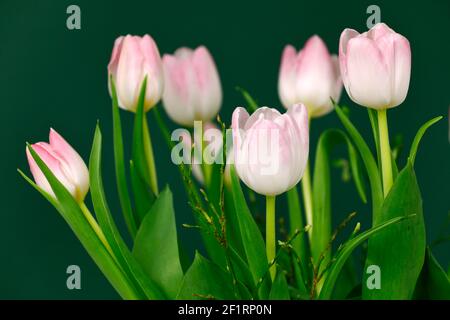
{"left": 133, "top": 187, "right": 183, "bottom": 298}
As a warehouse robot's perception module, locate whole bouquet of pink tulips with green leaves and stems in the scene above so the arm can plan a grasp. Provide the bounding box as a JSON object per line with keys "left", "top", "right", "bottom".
{"left": 19, "top": 23, "right": 450, "bottom": 300}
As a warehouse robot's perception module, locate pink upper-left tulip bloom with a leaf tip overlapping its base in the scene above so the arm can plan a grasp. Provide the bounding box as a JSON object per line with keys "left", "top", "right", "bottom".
{"left": 108, "top": 35, "right": 164, "bottom": 112}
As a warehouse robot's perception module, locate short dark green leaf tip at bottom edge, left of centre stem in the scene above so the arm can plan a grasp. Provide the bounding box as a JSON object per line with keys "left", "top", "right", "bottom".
{"left": 177, "top": 252, "right": 236, "bottom": 300}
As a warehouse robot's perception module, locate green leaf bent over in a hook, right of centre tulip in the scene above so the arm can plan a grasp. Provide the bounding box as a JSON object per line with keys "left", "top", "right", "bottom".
{"left": 311, "top": 129, "right": 366, "bottom": 265}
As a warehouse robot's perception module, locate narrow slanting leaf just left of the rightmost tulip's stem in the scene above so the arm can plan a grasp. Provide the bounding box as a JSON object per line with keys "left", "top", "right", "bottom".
{"left": 335, "top": 104, "right": 383, "bottom": 217}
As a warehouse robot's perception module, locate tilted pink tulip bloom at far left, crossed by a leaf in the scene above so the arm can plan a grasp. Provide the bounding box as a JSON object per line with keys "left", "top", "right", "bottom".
{"left": 26, "top": 129, "right": 89, "bottom": 202}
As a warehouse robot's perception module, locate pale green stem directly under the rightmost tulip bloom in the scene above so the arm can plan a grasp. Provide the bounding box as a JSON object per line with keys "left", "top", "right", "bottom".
{"left": 377, "top": 109, "right": 393, "bottom": 198}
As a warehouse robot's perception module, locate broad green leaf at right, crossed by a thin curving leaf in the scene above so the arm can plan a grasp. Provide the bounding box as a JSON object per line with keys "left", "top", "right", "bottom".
{"left": 363, "top": 161, "right": 425, "bottom": 300}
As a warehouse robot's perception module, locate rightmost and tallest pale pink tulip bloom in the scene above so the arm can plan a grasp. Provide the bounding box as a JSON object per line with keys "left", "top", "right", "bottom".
{"left": 339, "top": 23, "right": 411, "bottom": 109}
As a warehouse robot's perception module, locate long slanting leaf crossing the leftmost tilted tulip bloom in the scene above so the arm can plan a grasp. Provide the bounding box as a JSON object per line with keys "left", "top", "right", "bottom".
{"left": 28, "top": 146, "right": 140, "bottom": 299}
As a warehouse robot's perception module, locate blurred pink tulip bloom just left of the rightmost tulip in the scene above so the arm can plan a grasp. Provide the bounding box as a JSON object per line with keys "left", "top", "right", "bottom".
{"left": 278, "top": 36, "right": 342, "bottom": 117}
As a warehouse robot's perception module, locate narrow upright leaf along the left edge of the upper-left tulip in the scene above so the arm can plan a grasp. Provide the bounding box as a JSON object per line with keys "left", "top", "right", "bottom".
{"left": 110, "top": 76, "right": 137, "bottom": 239}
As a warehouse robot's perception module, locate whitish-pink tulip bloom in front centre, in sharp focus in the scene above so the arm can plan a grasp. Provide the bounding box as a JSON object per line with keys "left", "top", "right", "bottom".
{"left": 232, "top": 104, "right": 309, "bottom": 196}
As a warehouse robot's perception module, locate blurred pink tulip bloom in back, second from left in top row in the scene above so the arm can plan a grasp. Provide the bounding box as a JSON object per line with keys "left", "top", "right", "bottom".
{"left": 163, "top": 46, "right": 222, "bottom": 126}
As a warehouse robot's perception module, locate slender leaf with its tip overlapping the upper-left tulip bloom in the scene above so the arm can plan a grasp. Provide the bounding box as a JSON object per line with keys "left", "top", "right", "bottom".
{"left": 131, "top": 77, "right": 155, "bottom": 227}
